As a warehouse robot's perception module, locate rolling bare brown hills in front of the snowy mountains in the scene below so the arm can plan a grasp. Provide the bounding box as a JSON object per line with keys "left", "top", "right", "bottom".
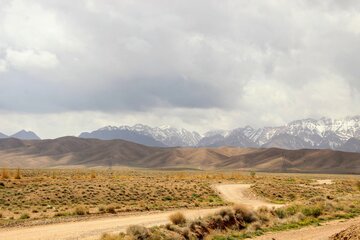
{"left": 0, "top": 137, "right": 360, "bottom": 173}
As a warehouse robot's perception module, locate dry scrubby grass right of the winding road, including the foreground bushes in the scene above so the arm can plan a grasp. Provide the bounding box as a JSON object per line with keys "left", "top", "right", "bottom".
{"left": 96, "top": 172, "right": 360, "bottom": 240}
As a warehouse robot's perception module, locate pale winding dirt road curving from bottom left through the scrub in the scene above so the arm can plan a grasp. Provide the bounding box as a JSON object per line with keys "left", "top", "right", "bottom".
{"left": 0, "top": 184, "right": 273, "bottom": 240}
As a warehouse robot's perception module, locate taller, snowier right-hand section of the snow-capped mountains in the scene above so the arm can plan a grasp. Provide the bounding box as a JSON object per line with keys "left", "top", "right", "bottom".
{"left": 201, "top": 116, "right": 360, "bottom": 150}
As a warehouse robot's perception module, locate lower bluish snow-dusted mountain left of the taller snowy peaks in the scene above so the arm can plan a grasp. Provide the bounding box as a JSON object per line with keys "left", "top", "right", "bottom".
{"left": 80, "top": 124, "right": 201, "bottom": 147}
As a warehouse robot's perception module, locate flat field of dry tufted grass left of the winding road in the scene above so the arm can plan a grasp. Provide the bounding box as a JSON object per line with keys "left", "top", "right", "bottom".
{"left": 0, "top": 168, "right": 229, "bottom": 226}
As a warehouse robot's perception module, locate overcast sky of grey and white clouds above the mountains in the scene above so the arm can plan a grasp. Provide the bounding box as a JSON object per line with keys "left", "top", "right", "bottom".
{"left": 0, "top": 0, "right": 360, "bottom": 138}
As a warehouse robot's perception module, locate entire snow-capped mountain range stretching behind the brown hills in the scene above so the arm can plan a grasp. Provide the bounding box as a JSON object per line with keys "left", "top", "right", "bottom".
{"left": 79, "top": 116, "right": 360, "bottom": 152}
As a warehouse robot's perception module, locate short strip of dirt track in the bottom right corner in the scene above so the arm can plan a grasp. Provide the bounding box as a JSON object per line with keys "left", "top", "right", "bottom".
{"left": 254, "top": 218, "right": 360, "bottom": 240}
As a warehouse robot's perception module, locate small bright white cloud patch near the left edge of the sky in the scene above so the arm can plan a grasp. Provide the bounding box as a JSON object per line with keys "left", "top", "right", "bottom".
{"left": 6, "top": 49, "right": 59, "bottom": 72}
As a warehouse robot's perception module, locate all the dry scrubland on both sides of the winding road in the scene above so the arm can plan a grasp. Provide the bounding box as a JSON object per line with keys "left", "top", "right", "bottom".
{"left": 0, "top": 169, "right": 360, "bottom": 240}
